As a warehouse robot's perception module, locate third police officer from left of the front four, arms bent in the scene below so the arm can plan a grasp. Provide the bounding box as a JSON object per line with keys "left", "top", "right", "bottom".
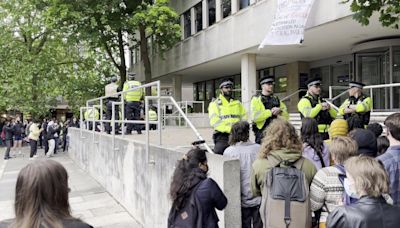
{"left": 297, "top": 78, "right": 337, "bottom": 140}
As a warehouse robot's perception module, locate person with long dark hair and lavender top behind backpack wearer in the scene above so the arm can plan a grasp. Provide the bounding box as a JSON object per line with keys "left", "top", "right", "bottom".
{"left": 300, "top": 118, "right": 330, "bottom": 170}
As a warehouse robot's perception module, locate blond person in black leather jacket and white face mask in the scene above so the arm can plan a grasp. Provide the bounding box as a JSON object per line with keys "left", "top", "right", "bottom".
{"left": 326, "top": 156, "right": 400, "bottom": 228}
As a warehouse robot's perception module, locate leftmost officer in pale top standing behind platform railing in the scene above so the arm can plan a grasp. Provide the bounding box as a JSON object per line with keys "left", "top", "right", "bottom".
{"left": 105, "top": 76, "right": 119, "bottom": 134}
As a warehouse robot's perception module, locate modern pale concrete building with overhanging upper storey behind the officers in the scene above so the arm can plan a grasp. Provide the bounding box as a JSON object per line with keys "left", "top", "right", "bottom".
{"left": 132, "top": 0, "right": 400, "bottom": 112}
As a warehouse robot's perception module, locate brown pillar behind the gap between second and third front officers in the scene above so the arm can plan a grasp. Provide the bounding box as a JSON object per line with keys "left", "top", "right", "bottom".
{"left": 286, "top": 62, "right": 310, "bottom": 112}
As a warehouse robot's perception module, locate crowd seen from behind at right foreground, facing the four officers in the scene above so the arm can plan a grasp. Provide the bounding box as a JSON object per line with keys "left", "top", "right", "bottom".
{"left": 168, "top": 113, "right": 400, "bottom": 228}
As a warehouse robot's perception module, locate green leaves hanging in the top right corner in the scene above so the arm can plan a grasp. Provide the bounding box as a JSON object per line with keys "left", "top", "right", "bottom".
{"left": 343, "top": 0, "right": 400, "bottom": 29}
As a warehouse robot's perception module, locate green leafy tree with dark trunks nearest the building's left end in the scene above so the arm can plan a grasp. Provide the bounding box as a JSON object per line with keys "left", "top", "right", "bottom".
{"left": 48, "top": 0, "right": 180, "bottom": 93}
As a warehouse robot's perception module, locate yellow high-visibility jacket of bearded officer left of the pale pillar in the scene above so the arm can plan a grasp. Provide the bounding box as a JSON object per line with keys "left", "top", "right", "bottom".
{"left": 208, "top": 95, "right": 247, "bottom": 134}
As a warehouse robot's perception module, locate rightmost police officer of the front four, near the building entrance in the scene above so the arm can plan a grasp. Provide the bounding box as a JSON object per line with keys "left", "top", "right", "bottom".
{"left": 339, "top": 81, "right": 372, "bottom": 127}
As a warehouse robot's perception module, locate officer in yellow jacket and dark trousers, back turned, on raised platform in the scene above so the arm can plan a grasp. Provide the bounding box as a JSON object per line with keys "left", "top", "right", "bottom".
{"left": 122, "top": 73, "right": 143, "bottom": 134}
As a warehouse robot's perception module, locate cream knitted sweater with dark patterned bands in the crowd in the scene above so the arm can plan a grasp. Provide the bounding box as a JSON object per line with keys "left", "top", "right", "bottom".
{"left": 310, "top": 166, "right": 344, "bottom": 222}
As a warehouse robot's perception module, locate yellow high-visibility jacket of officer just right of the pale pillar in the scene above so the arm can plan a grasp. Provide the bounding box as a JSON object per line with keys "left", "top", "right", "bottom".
{"left": 250, "top": 95, "right": 289, "bottom": 129}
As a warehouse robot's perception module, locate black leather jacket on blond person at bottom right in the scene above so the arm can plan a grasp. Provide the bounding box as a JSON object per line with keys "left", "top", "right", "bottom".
{"left": 326, "top": 196, "right": 400, "bottom": 228}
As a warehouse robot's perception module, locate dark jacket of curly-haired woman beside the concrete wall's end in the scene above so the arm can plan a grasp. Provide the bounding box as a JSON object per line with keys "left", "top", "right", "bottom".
{"left": 196, "top": 178, "right": 228, "bottom": 228}
